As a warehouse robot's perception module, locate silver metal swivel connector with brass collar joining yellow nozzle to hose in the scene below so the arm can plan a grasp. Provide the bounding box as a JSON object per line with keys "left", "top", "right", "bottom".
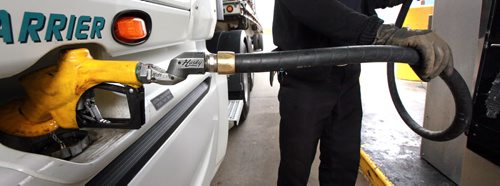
{"left": 136, "top": 52, "right": 235, "bottom": 85}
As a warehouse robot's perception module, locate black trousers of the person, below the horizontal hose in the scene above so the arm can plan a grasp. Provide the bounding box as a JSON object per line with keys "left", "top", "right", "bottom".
{"left": 278, "top": 65, "right": 362, "bottom": 186}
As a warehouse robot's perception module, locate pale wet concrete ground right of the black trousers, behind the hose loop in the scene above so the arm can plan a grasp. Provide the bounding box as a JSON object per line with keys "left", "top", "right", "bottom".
{"left": 360, "top": 63, "right": 454, "bottom": 185}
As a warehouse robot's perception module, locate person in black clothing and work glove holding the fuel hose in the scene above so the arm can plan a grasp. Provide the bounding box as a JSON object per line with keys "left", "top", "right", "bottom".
{"left": 273, "top": 0, "right": 453, "bottom": 185}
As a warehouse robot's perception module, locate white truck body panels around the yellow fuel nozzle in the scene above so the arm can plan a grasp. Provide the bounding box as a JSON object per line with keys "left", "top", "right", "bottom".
{"left": 0, "top": 0, "right": 228, "bottom": 185}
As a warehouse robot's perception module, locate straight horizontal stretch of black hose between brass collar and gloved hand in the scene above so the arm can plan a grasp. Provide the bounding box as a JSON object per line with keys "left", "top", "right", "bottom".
{"left": 235, "top": 45, "right": 420, "bottom": 73}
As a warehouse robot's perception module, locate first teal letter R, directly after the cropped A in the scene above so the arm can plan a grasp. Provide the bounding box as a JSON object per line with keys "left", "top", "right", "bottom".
{"left": 19, "top": 12, "right": 45, "bottom": 43}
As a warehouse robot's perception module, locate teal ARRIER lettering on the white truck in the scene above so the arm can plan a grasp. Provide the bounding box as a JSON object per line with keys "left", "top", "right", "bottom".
{"left": 0, "top": 10, "right": 106, "bottom": 44}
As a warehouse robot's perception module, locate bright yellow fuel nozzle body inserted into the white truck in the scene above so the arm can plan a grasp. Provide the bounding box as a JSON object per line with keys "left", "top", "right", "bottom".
{"left": 0, "top": 48, "right": 142, "bottom": 137}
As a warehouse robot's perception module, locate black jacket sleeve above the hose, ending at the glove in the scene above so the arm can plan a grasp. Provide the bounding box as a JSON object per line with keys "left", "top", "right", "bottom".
{"left": 277, "top": 0, "right": 383, "bottom": 44}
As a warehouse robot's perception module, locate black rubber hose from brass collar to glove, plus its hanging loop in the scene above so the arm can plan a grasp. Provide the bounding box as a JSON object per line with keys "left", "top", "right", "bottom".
{"left": 235, "top": 45, "right": 472, "bottom": 141}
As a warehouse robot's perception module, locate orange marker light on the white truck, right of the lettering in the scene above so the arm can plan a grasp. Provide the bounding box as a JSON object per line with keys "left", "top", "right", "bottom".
{"left": 115, "top": 17, "right": 148, "bottom": 43}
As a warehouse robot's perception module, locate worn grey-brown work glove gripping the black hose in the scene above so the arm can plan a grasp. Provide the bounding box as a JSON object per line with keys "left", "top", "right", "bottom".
{"left": 374, "top": 25, "right": 453, "bottom": 81}
